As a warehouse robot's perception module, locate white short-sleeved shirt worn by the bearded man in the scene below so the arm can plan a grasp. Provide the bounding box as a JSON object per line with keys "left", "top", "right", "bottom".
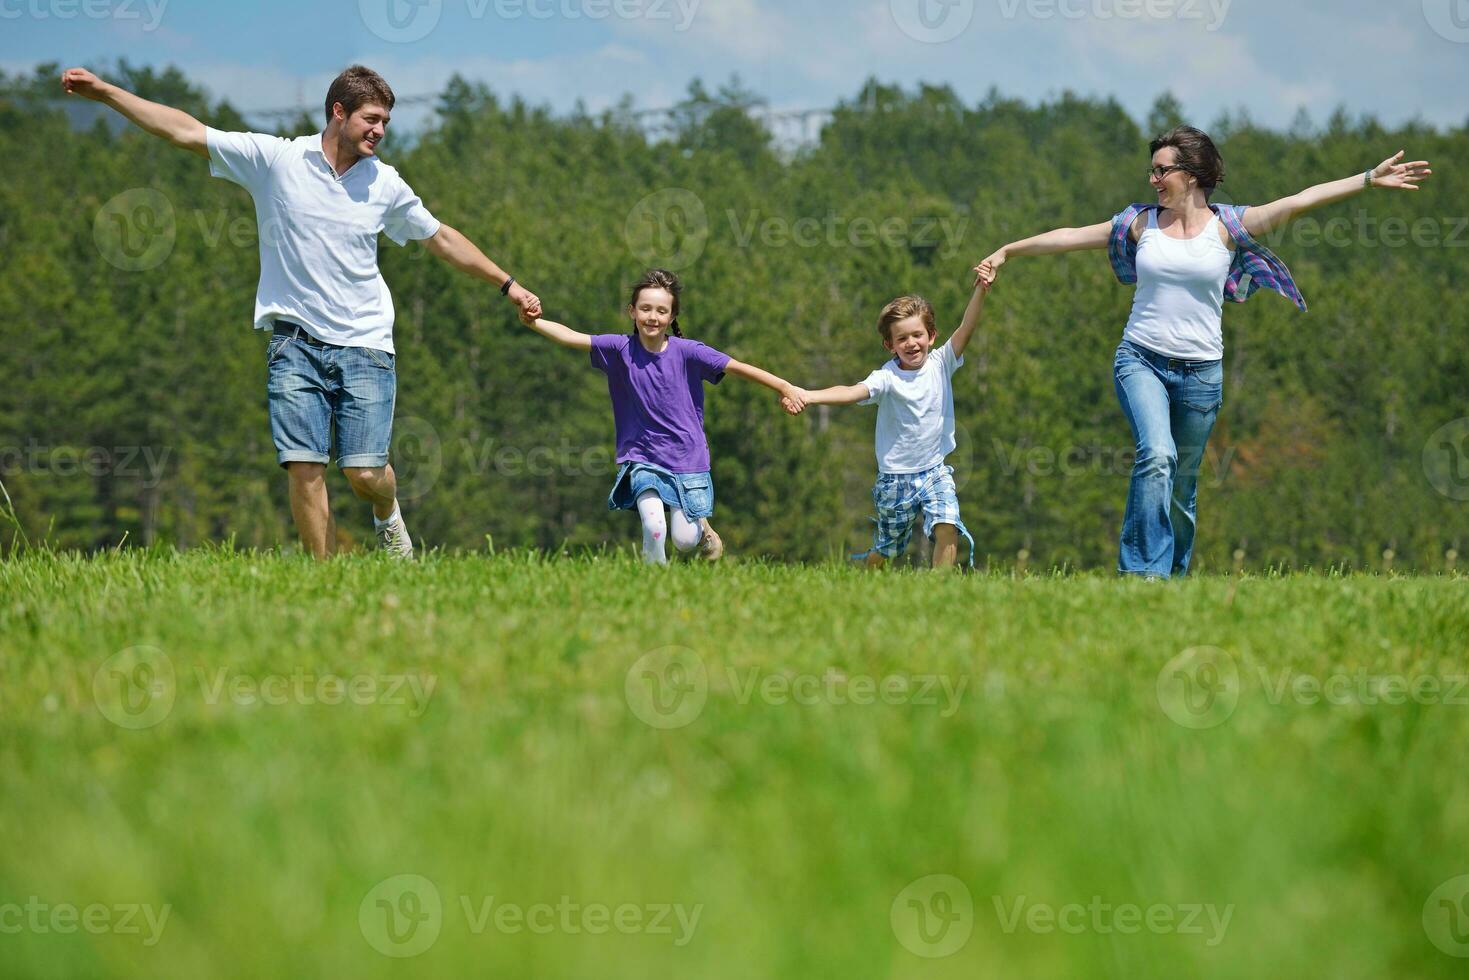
{"left": 207, "top": 129, "right": 439, "bottom": 354}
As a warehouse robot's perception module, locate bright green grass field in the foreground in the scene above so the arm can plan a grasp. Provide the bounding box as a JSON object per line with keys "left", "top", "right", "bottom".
{"left": 0, "top": 552, "right": 1469, "bottom": 980}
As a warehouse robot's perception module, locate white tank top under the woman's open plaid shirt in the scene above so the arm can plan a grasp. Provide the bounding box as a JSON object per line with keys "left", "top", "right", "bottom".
{"left": 1122, "top": 209, "right": 1234, "bottom": 360}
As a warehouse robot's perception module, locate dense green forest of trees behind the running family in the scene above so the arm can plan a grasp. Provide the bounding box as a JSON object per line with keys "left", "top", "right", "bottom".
{"left": 0, "top": 65, "right": 1469, "bottom": 572}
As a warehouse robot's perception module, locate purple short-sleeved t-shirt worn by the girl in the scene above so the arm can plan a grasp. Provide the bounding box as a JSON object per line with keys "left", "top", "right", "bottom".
{"left": 592, "top": 334, "right": 730, "bottom": 473}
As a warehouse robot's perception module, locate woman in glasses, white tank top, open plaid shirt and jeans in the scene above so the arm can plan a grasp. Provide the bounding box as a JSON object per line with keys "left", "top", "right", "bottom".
{"left": 980, "top": 126, "right": 1432, "bottom": 579}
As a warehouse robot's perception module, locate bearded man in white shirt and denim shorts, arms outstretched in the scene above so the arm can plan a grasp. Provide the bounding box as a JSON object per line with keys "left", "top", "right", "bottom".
{"left": 62, "top": 65, "right": 541, "bottom": 558}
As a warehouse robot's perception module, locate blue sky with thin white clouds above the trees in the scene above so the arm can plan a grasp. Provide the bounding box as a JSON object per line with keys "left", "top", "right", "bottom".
{"left": 0, "top": 0, "right": 1469, "bottom": 134}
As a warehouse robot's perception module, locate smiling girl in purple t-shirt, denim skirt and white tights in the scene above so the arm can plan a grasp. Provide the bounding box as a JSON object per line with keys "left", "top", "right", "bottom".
{"left": 520, "top": 269, "right": 805, "bottom": 564}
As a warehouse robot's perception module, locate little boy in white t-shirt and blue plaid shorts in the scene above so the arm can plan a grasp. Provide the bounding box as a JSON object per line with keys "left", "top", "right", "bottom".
{"left": 787, "top": 269, "right": 989, "bottom": 569}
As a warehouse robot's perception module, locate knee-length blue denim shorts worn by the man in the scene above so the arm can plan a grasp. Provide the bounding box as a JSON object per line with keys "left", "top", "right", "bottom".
{"left": 266, "top": 327, "right": 398, "bottom": 467}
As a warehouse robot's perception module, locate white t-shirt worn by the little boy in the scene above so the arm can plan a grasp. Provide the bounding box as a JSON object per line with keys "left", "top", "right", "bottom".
{"left": 861, "top": 342, "right": 964, "bottom": 473}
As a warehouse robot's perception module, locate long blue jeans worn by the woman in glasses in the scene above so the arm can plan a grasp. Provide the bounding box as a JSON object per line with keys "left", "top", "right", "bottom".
{"left": 1112, "top": 341, "right": 1224, "bottom": 579}
